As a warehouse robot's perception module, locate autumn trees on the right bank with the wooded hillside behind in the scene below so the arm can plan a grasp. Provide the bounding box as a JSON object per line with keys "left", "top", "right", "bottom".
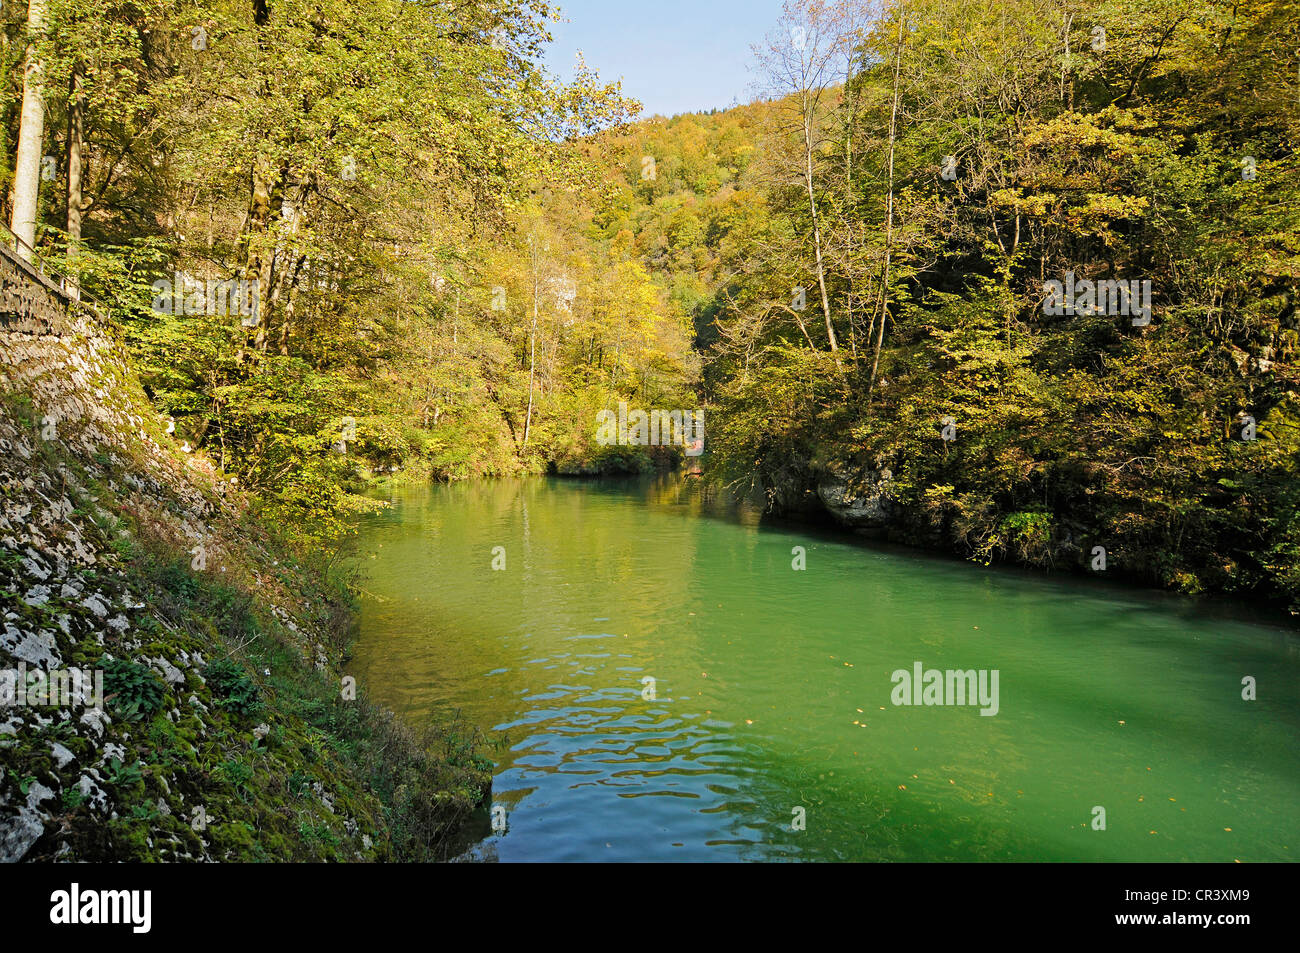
{"left": 594, "top": 0, "right": 1300, "bottom": 610}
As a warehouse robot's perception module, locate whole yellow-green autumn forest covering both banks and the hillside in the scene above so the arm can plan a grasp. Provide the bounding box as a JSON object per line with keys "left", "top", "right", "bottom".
{"left": 0, "top": 0, "right": 1300, "bottom": 608}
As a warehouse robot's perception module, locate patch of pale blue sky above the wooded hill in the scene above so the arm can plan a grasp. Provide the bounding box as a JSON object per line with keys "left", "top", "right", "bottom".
{"left": 546, "top": 0, "right": 781, "bottom": 116}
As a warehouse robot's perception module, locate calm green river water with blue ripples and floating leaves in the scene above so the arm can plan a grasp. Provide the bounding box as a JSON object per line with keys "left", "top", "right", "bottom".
{"left": 351, "top": 476, "right": 1300, "bottom": 862}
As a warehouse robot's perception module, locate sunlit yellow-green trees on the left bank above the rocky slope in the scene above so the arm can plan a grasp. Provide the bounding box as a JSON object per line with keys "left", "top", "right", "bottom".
{"left": 30, "top": 0, "right": 692, "bottom": 556}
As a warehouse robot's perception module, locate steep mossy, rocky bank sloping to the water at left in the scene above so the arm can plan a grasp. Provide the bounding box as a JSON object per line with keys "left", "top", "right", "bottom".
{"left": 0, "top": 265, "right": 490, "bottom": 862}
